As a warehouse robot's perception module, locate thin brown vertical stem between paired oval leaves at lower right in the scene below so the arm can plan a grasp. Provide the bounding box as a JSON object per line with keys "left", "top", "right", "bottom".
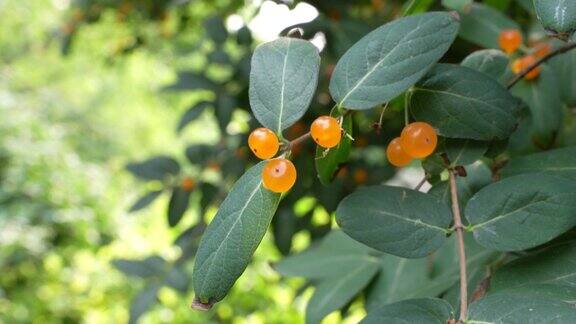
{"left": 450, "top": 170, "right": 468, "bottom": 323}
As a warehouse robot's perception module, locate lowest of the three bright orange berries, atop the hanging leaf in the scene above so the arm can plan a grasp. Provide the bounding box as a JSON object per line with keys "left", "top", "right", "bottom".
{"left": 262, "top": 158, "right": 296, "bottom": 193}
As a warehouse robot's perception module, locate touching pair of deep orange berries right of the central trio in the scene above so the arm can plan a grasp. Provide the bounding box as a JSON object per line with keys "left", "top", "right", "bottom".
{"left": 386, "top": 122, "right": 438, "bottom": 167}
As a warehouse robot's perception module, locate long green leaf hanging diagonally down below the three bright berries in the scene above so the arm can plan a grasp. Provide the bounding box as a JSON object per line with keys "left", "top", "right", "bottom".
{"left": 192, "top": 161, "right": 280, "bottom": 307}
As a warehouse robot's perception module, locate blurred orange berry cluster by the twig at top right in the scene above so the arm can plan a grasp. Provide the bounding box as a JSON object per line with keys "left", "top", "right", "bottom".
{"left": 498, "top": 29, "right": 551, "bottom": 80}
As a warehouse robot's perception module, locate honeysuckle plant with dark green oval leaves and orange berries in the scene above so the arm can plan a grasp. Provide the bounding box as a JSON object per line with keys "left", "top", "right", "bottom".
{"left": 121, "top": 0, "right": 576, "bottom": 323}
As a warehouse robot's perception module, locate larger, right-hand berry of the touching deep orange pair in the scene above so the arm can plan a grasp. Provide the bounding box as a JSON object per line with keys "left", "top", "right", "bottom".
{"left": 400, "top": 122, "right": 438, "bottom": 159}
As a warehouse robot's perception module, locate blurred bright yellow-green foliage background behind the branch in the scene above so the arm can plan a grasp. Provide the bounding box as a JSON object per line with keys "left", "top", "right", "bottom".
{"left": 0, "top": 0, "right": 432, "bottom": 324}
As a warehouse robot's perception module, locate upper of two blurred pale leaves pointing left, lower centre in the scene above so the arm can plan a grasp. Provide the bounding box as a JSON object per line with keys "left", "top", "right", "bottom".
{"left": 274, "top": 230, "right": 379, "bottom": 279}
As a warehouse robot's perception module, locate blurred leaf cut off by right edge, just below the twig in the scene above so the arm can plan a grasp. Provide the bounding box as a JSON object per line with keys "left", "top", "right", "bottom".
{"left": 550, "top": 46, "right": 576, "bottom": 107}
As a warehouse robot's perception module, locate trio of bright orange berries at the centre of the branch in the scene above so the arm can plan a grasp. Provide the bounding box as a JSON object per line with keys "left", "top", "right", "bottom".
{"left": 248, "top": 116, "right": 342, "bottom": 193}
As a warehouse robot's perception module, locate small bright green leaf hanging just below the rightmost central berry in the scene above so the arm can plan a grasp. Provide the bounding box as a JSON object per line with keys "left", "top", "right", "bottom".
{"left": 315, "top": 115, "right": 352, "bottom": 186}
